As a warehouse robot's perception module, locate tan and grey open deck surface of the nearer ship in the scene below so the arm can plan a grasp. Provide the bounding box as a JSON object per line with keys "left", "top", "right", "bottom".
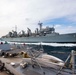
{"left": 0, "top": 58, "right": 76, "bottom": 75}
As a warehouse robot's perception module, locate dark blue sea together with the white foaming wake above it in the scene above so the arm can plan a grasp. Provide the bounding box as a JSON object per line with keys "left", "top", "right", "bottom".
{"left": 29, "top": 43, "right": 76, "bottom": 61}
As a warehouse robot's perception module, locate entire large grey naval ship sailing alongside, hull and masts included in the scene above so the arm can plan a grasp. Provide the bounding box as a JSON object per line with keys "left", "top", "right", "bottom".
{"left": 1, "top": 22, "right": 76, "bottom": 43}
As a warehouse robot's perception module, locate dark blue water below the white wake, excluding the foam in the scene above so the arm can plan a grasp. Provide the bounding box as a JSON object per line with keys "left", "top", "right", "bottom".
{"left": 43, "top": 45, "right": 76, "bottom": 61}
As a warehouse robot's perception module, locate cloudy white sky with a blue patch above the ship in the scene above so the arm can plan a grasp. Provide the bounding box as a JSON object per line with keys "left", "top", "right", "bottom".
{"left": 0, "top": 0, "right": 76, "bottom": 37}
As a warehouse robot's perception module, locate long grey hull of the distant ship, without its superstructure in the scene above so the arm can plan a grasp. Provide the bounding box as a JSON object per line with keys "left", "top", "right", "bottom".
{"left": 2, "top": 33, "right": 76, "bottom": 43}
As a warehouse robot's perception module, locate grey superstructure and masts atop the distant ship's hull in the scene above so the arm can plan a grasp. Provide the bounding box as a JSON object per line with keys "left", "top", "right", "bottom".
{"left": 2, "top": 22, "right": 56, "bottom": 38}
